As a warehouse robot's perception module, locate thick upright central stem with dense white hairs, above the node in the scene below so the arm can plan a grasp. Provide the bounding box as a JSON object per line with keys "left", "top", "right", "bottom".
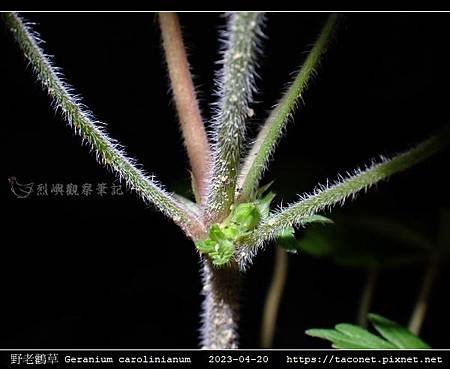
{"left": 206, "top": 12, "right": 263, "bottom": 222}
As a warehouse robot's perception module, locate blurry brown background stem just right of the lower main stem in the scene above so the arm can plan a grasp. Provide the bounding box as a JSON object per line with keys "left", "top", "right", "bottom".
{"left": 261, "top": 247, "right": 288, "bottom": 348}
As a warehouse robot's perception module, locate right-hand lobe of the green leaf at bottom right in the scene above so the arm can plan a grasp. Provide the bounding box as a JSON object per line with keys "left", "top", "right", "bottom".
{"left": 369, "top": 314, "right": 430, "bottom": 349}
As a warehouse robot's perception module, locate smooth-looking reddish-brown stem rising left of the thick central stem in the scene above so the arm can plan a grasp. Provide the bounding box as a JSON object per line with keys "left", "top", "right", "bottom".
{"left": 159, "top": 13, "right": 211, "bottom": 198}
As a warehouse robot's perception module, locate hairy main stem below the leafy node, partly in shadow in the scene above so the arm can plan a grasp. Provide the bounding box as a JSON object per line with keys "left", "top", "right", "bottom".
{"left": 200, "top": 258, "right": 241, "bottom": 349}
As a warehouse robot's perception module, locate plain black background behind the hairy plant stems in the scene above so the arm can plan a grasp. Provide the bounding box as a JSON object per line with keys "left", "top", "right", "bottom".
{"left": 0, "top": 13, "right": 450, "bottom": 348}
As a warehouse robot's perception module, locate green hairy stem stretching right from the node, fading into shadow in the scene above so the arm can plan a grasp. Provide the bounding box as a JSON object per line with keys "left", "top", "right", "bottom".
{"left": 236, "top": 125, "right": 450, "bottom": 269}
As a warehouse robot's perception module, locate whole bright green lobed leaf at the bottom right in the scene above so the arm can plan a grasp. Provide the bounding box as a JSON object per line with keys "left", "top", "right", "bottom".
{"left": 305, "top": 314, "right": 430, "bottom": 349}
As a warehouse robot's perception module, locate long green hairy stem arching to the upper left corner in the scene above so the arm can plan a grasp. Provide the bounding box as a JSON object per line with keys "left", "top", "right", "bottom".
{"left": 3, "top": 13, "right": 204, "bottom": 238}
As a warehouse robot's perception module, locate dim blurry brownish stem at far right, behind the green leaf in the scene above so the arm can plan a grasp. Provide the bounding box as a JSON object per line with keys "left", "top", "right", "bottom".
{"left": 408, "top": 256, "right": 439, "bottom": 336}
